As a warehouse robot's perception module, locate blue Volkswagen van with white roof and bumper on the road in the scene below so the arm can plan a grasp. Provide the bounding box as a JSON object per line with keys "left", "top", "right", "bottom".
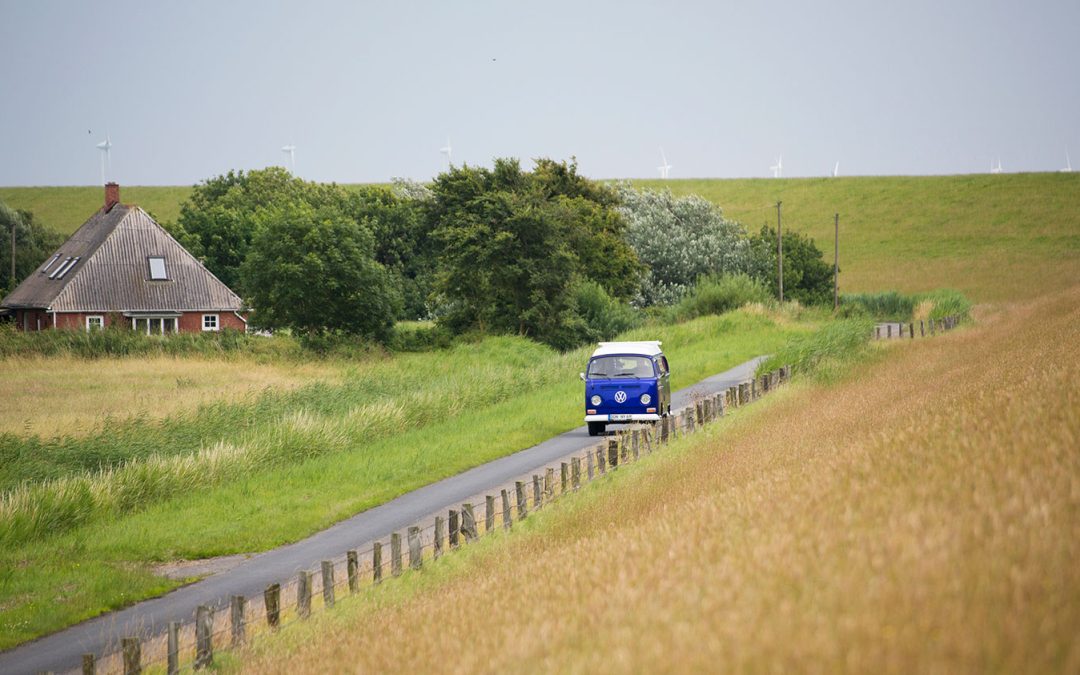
{"left": 581, "top": 341, "right": 672, "bottom": 436}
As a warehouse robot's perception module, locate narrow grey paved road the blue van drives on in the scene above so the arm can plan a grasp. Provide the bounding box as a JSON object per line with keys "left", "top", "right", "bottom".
{"left": 0, "top": 359, "right": 758, "bottom": 674}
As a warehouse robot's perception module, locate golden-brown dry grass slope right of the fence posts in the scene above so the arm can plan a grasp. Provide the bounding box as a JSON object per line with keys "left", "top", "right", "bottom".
{"left": 236, "top": 287, "right": 1080, "bottom": 673}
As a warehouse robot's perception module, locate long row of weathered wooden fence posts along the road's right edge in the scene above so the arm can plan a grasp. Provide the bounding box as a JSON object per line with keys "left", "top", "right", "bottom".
{"left": 69, "top": 365, "right": 792, "bottom": 675}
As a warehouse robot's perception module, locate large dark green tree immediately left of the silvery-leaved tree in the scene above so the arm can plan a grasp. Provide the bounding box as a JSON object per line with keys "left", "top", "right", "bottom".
{"left": 430, "top": 159, "right": 642, "bottom": 348}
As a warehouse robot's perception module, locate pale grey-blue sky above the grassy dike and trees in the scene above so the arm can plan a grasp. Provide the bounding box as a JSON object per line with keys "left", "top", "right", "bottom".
{"left": 0, "top": 0, "right": 1080, "bottom": 186}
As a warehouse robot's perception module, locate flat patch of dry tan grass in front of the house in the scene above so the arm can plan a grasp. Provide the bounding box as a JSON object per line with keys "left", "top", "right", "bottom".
{"left": 0, "top": 356, "right": 341, "bottom": 437}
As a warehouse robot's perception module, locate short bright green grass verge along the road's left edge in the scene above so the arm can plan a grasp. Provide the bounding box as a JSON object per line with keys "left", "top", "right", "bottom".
{"left": 0, "top": 311, "right": 812, "bottom": 649}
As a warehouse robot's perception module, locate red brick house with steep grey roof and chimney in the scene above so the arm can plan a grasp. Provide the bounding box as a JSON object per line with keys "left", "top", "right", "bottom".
{"left": 0, "top": 183, "right": 247, "bottom": 335}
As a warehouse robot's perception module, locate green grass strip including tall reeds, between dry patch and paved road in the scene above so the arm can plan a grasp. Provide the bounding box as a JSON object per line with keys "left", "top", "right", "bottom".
{"left": 0, "top": 311, "right": 808, "bottom": 648}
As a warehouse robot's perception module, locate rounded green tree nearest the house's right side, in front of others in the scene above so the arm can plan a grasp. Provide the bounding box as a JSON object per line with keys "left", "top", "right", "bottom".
{"left": 241, "top": 201, "right": 401, "bottom": 342}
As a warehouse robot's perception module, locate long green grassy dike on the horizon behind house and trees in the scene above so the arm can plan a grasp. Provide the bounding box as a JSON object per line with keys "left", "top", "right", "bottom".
{"left": 0, "top": 173, "right": 1080, "bottom": 301}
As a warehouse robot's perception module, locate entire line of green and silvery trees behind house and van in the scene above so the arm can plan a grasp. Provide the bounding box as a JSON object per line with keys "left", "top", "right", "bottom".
{"left": 0, "top": 159, "right": 832, "bottom": 349}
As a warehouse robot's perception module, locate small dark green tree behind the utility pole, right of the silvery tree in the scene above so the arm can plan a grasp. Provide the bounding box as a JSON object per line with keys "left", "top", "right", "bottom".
{"left": 751, "top": 226, "right": 833, "bottom": 305}
